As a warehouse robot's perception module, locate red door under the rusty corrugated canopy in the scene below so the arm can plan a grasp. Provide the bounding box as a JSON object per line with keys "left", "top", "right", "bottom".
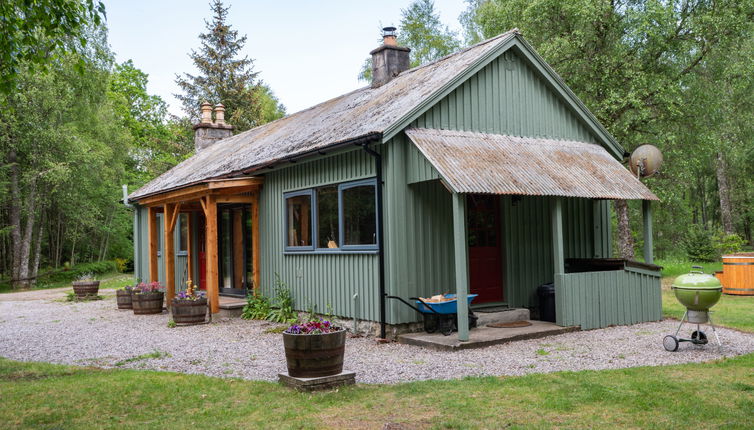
{"left": 466, "top": 194, "right": 504, "bottom": 303}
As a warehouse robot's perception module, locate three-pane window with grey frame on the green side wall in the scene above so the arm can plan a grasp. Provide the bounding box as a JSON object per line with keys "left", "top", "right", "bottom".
{"left": 284, "top": 179, "right": 377, "bottom": 252}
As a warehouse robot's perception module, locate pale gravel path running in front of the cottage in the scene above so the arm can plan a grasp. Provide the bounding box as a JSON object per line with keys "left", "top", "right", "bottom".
{"left": 0, "top": 297, "right": 754, "bottom": 383}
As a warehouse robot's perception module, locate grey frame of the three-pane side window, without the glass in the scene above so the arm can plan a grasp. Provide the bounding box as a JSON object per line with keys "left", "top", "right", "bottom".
{"left": 283, "top": 177, "right": 380, "bottom": 255}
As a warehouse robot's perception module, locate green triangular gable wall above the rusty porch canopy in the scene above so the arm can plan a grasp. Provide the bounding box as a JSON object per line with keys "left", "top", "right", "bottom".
{"left": 412, "top": 51, "right": 597, "bottom": 143}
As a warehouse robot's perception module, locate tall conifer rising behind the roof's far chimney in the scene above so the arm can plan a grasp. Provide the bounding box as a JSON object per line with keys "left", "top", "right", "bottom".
{"left": 175, "top": 0, "right": 264, "bottom": 131}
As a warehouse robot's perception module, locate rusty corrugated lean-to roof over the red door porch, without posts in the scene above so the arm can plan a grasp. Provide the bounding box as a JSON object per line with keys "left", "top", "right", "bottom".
{"left": 406, "top": 129, "right": 659, "bottom": 200}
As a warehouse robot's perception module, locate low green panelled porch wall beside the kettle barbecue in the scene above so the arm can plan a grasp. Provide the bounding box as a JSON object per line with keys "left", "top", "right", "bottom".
{"left": 555, "top": 268, "right": 662, "bottom": 330}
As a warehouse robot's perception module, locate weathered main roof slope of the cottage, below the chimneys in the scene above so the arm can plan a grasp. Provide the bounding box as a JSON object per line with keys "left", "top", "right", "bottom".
{"left": 129, "top": 30, "right": 517, "bottom": 200}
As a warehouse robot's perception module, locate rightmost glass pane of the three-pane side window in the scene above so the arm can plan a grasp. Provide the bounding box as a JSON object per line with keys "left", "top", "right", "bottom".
{"left": 343, "top": 184, "right": 377, "bottom": 245}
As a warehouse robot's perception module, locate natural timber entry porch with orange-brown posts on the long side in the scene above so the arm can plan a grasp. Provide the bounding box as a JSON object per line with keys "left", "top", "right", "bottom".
{"left": 138, "top": 177, "right": 263, "bottom": 313}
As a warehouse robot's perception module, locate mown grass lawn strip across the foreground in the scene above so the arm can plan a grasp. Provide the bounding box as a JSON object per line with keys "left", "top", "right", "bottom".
{"left": 0, "top": 354, "right": 754, "bottom": 429}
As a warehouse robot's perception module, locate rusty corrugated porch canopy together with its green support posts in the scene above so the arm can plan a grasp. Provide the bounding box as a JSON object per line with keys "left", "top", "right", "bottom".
{"left": 406, "top": 128, "right": 659, "bottom": 341}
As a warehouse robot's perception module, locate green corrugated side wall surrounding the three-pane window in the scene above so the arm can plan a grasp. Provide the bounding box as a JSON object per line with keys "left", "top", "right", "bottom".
{"left": 259, "top": 149, "right": 379, "bottom": 321}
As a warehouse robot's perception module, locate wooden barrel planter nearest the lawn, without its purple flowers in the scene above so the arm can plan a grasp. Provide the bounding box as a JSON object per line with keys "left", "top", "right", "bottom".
{"left": 283, "top": 330, "right": 346, "bottom": 378}
